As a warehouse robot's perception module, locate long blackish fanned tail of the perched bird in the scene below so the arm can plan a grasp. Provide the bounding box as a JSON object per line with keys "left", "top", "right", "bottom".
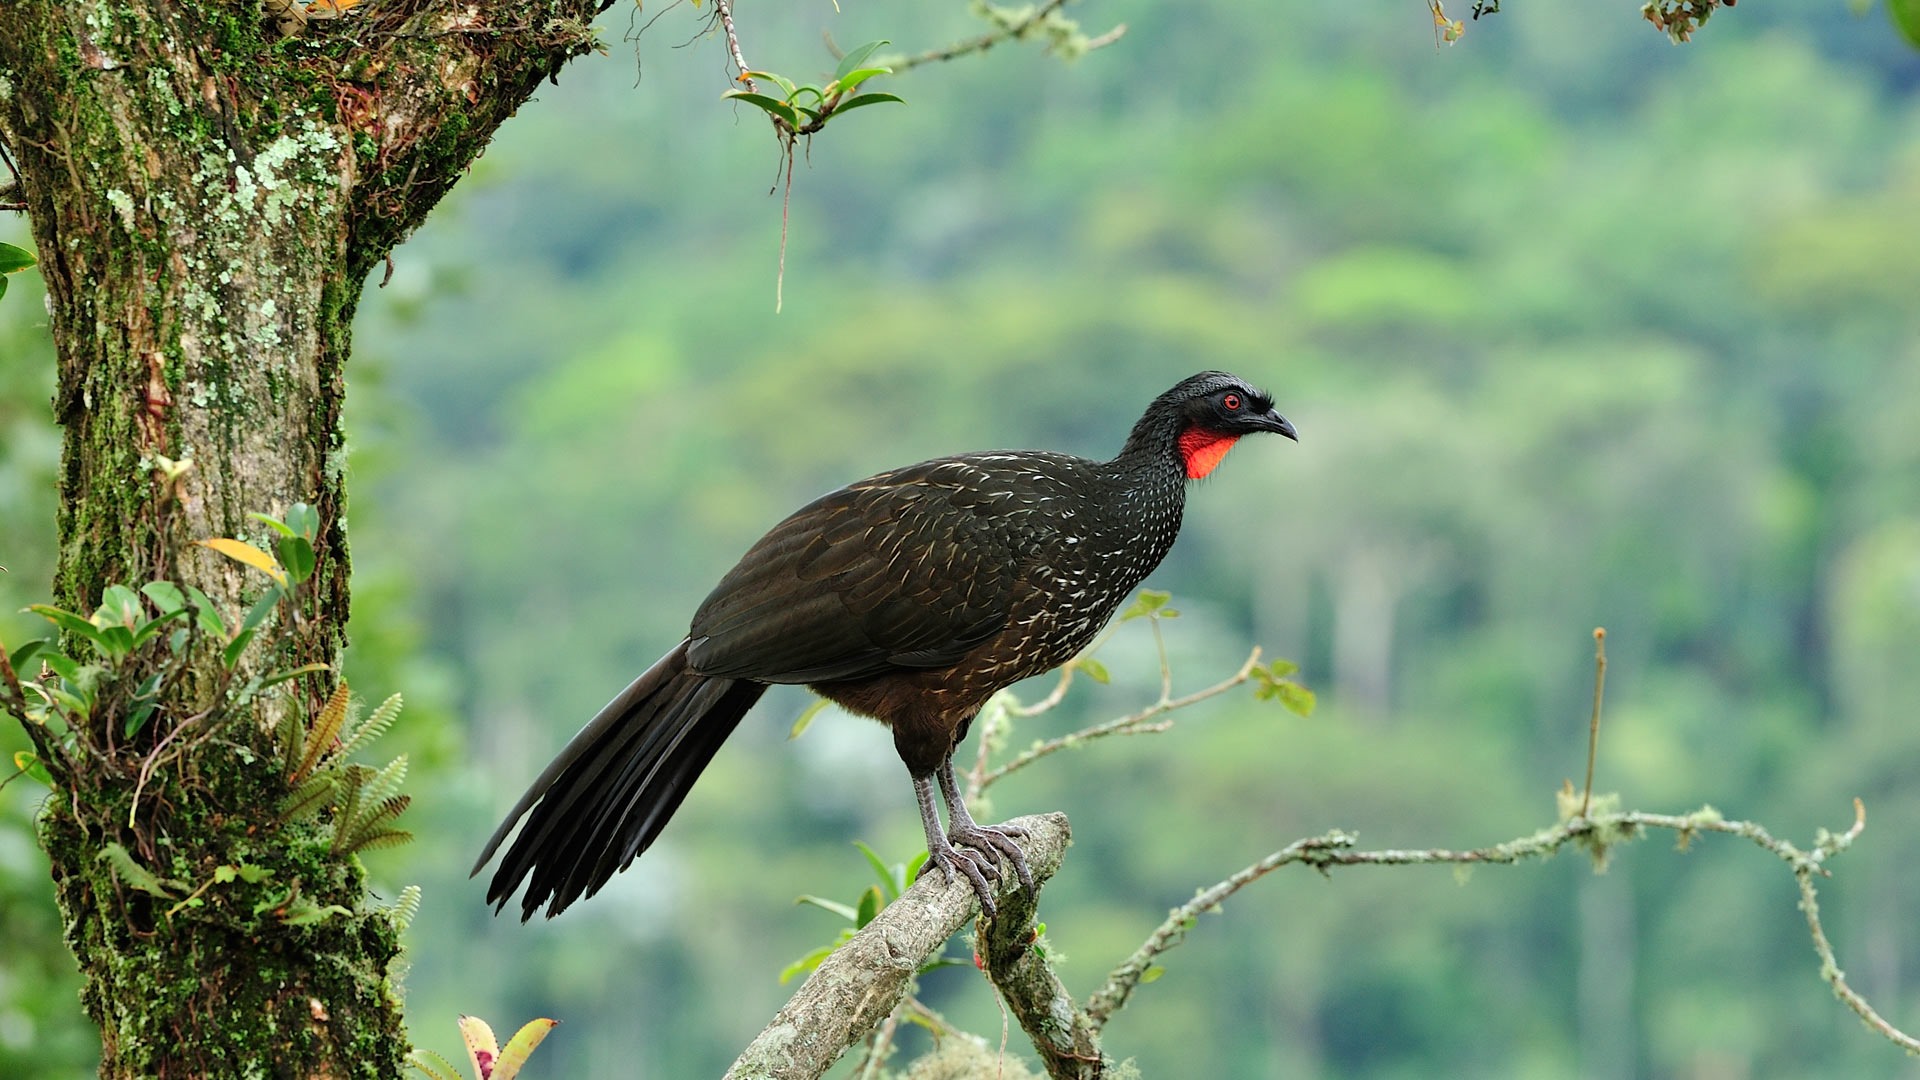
{"left": 472, "top": 642, "right": 766, "bottom": 920}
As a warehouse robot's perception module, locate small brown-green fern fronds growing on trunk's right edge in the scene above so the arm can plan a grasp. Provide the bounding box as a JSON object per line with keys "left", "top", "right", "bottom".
{"left": 276, "top": 682, "right": 413, "bottom": 855}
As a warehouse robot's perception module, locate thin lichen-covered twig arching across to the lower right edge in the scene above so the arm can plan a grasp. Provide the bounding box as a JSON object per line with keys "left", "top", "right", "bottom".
{"left": 1087, "top": 799, "right": 1920, "bottom": 1053}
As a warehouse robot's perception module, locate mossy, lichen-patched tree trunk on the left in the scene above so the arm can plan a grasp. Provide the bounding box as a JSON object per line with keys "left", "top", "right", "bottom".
{"left": 0, "top": 0, "right": 603, "bottom": 1078}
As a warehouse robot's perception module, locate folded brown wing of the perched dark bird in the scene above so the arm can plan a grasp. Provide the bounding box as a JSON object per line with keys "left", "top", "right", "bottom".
{"left": 687, "top": 459, "right": 1046, "bottom": 682}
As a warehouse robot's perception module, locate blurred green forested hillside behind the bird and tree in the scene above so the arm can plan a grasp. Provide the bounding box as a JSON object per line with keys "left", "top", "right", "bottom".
{"left": 0, "top": 0, "right": 1920, "bottom": 1080}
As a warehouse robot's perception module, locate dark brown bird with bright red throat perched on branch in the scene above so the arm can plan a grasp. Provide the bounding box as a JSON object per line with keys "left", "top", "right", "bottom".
{"left": 472, "top": 371, "right": 1300, "bottom": 922}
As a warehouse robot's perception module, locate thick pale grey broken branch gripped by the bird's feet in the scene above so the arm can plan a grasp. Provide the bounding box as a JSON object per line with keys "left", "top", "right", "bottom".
{"left": 726, "top": 813, "right": 1071, "bottom": 1080}
